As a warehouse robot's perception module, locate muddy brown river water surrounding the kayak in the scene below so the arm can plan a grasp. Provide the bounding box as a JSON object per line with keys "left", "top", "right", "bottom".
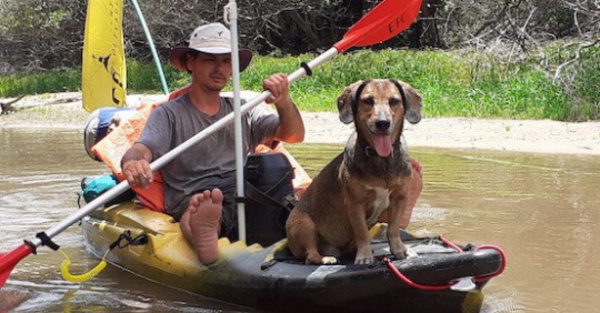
{"left": 0, "top": 129, "right": 600, "bottom": 313}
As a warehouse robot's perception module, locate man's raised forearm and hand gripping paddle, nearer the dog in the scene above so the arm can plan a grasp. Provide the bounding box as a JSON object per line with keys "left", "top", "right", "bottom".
{"left": 263, "top": 74, "right": 304, "bottom": 143}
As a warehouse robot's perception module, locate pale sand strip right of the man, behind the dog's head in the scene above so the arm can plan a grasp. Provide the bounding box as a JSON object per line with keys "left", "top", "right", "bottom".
{"left": 304, "top": 113, "right": 600, "bottom": 155}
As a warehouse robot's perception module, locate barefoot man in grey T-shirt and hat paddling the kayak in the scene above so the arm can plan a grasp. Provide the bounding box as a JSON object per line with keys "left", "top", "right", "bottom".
{"left": 121, "top": 23, "right": 304, "bottom": 264}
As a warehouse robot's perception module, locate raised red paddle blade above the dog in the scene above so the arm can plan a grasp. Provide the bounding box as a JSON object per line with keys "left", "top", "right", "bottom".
{"left": 333, "top": 0, "right": 421, "bottom": 53}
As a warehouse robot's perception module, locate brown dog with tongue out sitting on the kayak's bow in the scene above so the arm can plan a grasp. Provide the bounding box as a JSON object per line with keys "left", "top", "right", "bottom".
{"left": 286, "top": 79, "right": 421, "bottom": 264}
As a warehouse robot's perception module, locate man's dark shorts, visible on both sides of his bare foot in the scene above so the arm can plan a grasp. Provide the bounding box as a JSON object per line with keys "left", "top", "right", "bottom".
{"left": 167, "top": 186, "right": 238, "bottom": 241}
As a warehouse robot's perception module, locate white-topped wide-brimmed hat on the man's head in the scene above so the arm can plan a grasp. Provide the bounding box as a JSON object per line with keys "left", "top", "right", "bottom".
{"left": 169, "top": 23, "right": 252, "bottom": 72}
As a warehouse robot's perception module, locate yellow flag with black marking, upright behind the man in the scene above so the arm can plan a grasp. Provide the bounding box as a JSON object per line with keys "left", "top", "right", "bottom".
{"left": 81, "top": 0, "right": 127, "bottom": 112}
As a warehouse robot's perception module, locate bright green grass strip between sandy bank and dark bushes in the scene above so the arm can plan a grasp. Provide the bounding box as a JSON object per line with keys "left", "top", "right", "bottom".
{"left": 0, "top": 50, "right": 600, "bottom": 121}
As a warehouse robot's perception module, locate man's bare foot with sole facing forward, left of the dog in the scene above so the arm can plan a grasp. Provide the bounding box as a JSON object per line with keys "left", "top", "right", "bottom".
{"left": 187, "top": 189, "right": 223, "bottom": 264}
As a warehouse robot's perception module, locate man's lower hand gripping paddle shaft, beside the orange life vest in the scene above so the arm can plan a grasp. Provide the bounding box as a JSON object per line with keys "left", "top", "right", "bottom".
{"left": 121, "top": 143, "right": 154, "bottom": 188}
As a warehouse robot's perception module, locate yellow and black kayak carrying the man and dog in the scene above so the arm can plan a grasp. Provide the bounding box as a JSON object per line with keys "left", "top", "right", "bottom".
{"left": 81, "top": 202, "right": 504, "bottom": 313}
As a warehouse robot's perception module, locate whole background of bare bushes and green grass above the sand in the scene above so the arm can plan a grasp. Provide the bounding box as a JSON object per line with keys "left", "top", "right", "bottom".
{"left": 0, "top": 0, "right": 600, "bottom": 120}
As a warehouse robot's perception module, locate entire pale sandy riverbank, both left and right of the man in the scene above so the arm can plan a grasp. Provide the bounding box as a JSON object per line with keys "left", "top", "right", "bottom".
{"left": 0, "top": 93, "right": 600, "bottom": 155}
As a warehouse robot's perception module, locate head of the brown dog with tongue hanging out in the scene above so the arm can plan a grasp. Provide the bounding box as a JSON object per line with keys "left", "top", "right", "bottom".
{"left": 337, "top": 79, "right": 421, "bottom": 157}
